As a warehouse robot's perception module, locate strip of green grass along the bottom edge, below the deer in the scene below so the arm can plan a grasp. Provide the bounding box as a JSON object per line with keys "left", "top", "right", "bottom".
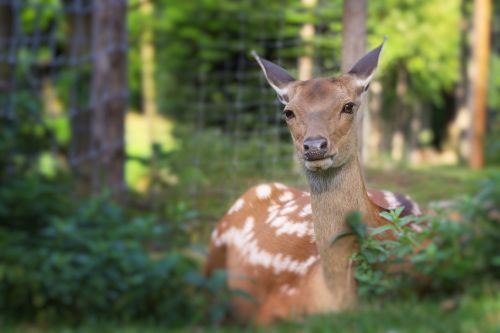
{"left": 0, "top": 286, "right": 500, "bottom": 333}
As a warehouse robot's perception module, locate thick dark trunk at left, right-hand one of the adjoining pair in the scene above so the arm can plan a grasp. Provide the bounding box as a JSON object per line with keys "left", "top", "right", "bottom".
{"left": 90, "top": 0, "right": 127, "bottom": 193}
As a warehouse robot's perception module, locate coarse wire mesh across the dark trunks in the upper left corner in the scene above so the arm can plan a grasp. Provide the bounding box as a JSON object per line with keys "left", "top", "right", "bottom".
{"left": 0, "top": 0, "right": 128, "bottom": 192}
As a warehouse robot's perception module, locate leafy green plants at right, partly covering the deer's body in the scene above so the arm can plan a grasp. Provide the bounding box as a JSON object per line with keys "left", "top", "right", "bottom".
{"left": 348, "top": 177, "right": 500, "bottom": 297}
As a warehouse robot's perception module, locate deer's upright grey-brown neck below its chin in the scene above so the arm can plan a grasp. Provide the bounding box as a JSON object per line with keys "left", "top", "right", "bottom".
{"left": 306, "top": 156, "right": 373, "bottom": 307}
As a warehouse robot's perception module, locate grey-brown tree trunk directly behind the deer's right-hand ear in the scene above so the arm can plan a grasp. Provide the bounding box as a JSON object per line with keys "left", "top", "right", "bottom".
{"left": 341, "top": 0, "right": 369, "bottom": 161}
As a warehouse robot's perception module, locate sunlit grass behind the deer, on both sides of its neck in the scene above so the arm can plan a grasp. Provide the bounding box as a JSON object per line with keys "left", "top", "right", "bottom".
{"left": 189, "top": 166, "right": 500, "bottom": 231}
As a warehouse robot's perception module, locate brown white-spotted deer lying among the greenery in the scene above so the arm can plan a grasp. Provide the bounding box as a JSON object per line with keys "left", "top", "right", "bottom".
{"left": 205, "top": 44, "right": 420, "bottom": 324}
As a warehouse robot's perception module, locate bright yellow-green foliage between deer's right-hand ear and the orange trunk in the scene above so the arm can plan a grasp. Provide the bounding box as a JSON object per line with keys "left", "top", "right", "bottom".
{"left": 368, "top": 0, "right": 460, "bottom": 103}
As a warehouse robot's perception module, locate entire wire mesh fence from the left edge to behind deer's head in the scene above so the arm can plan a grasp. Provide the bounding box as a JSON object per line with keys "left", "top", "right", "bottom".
{"left": 0, "top": 0, "right": 341, "bottom": 223}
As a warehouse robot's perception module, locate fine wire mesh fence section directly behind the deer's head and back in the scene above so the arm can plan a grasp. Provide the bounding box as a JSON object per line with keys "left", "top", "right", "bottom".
{"left": 140, "top": 0, "right": 341, "bottom": 223}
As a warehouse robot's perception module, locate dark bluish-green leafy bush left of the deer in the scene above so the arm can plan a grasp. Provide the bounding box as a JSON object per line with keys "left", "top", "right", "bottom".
{"left": 0, "top": 176, "right": 223, "bottom": 325}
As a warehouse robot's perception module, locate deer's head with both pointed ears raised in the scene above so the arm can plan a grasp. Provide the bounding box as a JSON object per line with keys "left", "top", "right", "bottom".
{"left": 253, "top": 43, "right": 384, "bottom": 172}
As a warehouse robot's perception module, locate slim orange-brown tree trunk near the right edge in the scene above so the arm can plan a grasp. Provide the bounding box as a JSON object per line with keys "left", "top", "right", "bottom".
{"left": 469, "top": 0, "right": 492, "bottom": 169}
